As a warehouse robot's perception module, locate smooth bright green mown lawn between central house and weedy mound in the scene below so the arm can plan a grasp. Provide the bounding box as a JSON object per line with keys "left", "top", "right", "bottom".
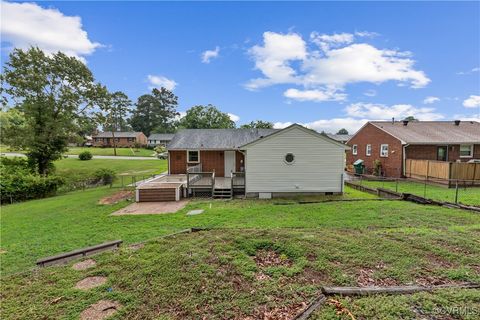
{"left": 1, "top": 188, "right": 480, "bottom": 273}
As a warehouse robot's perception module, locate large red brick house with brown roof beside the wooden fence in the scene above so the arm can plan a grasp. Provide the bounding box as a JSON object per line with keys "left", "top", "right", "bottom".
{"left": 347, "top": 120, "right": 480, "bottom": 177}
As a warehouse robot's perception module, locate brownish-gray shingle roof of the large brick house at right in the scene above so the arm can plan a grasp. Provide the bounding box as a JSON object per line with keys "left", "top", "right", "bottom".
{"left": 371, "top": 121, "right": 480, "bottom": 144}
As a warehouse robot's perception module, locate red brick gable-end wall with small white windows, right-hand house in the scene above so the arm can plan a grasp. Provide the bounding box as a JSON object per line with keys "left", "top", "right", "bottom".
{"left": 347, "top": 123, "right": 402, "bottom": 177}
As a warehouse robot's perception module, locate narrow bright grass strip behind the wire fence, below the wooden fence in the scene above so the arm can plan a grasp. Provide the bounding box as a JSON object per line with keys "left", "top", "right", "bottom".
{"left": 361, "top": 180, "right": 480, "bottom": 206}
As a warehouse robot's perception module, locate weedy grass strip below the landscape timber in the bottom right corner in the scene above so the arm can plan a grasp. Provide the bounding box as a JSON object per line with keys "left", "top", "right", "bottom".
{"left": 310, "top": 289, "right": 480, "bottom": 320}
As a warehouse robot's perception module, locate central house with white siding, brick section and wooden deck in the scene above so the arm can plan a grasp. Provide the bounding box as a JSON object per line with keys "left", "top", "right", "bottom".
{"left": 137, "top": 124, "right": 349, "bottom": 201}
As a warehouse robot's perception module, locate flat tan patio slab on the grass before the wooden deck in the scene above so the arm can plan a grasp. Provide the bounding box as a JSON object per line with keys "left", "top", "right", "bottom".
{"left": 111, "top": 200, "right": 189, "bottom": 216}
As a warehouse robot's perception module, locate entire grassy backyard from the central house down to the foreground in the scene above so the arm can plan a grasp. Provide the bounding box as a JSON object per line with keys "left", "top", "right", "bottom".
{"left": 1, "top": 188, "right": 480, "bottom": 319}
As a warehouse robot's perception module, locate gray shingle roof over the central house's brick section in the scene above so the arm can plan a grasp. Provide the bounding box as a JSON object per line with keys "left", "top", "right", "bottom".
{"left": 167, "top": 129, "right": 279, "bottom": 150}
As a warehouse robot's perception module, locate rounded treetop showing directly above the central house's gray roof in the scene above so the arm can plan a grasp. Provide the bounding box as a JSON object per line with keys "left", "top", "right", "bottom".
{"left": 179, "top": 104, "right": 235, "bottom": 129}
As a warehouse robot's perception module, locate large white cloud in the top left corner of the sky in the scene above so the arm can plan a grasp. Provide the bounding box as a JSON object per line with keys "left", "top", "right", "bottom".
{"left": 1, "top": 1, "right": 101, "bottom": 61}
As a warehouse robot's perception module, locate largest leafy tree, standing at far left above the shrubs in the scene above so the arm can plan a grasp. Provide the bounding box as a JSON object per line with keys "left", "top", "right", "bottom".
{"left": 1, "top": 47, "right": 106, "bottom": 175}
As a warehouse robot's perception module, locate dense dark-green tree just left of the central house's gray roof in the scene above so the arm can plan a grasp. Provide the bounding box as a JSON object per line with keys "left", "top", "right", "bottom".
{"left": 129, "top": 88, "right": 179, "bottom": 136}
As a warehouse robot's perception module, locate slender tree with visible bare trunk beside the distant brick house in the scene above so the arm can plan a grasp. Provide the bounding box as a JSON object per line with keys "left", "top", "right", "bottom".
{"left": 97, "top": 91, "right": 132, "bottom": 156}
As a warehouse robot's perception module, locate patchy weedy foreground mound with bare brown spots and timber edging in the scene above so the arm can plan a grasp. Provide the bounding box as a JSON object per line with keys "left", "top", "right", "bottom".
{"left": 2, "top": 227, "right": 479, "bottom": 319}
